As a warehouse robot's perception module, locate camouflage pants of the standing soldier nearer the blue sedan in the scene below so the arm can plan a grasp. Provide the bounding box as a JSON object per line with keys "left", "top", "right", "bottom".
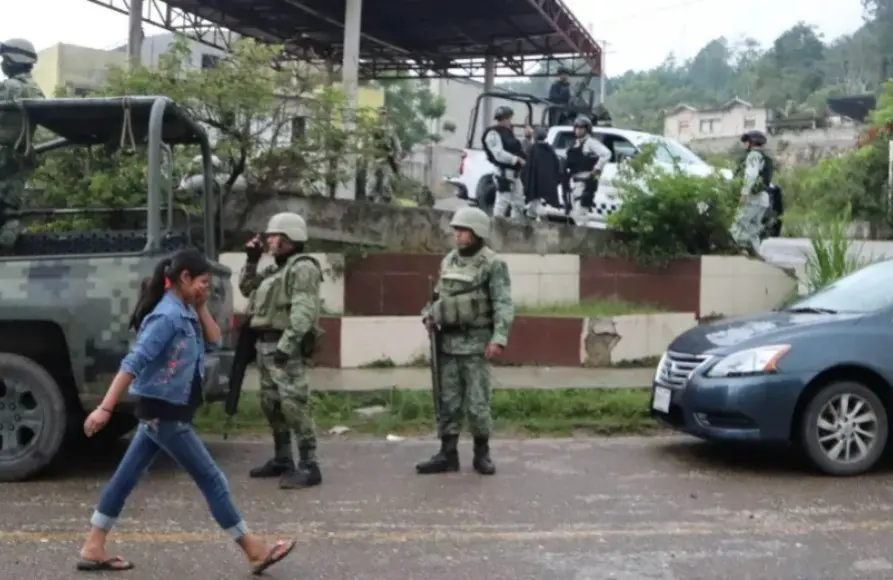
{"left": 437, "top": 354, "right": 493, "bottom": 437}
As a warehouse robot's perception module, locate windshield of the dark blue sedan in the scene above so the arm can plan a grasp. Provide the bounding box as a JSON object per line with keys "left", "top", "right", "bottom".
{"left": 785, "top": 260, "right": 893, "bottom": 313}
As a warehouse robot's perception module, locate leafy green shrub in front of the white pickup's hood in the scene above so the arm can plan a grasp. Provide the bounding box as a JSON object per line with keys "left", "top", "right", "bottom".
{"left": 608, "top": 148, "right": 740, "bottom": 262}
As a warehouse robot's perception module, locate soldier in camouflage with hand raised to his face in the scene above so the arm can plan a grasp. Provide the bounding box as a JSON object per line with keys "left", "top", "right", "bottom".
{"left": 239, "top": 213, "right": 323, "bottom": 489}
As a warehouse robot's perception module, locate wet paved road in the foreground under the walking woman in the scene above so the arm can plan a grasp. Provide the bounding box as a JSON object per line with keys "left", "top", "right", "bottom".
{"left": 0, "top": 438, "right": 893, "bottom": 580}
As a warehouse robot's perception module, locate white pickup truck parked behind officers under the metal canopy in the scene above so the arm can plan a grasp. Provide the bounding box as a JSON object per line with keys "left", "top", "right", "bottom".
{"left": 444, "top": 125, "right": 732, "bottom": 229}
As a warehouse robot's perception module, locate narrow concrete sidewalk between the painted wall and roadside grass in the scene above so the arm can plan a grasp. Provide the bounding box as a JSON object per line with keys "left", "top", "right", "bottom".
{"left": 245, "top": 367, "right": 654, "bottom": 391}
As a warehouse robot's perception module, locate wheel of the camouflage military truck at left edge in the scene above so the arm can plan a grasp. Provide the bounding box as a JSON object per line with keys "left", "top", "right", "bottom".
{"left": 0, "top": 353, "right": 68, "bottom": 481}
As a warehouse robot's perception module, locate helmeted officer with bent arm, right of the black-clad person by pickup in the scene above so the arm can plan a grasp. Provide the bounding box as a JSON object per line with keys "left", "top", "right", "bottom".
{"left": 566, "top": 116, "right": 611, "bottom": 225}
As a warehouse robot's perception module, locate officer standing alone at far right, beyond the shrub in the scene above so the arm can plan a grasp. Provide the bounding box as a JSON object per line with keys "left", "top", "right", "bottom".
{"left": 731, "top": 131, "right": 773, "bottom": 256}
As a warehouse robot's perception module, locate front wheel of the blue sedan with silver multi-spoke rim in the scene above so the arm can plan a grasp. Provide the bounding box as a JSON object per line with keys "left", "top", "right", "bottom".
{"left": 801, "top": 381, "right": 888, "bottom": 477}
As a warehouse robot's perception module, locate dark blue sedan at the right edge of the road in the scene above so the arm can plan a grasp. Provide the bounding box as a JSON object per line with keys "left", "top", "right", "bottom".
{"left": 651, "top": 261, "right": 893, "bottom": 476}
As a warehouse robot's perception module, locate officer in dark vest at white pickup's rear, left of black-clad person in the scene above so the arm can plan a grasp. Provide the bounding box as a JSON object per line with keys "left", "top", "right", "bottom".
{"left": 481, "top": 106, "right": 526, "bottom": 218}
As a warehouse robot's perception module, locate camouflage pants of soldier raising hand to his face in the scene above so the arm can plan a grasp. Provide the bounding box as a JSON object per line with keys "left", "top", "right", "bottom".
{"left": 257, "top": 342, "right": 316, "bottom": 455}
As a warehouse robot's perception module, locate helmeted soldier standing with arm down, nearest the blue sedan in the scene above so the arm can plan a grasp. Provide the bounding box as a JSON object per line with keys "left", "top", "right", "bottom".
{"left": 416, "top": 207, "right": 515, "bottom": 475}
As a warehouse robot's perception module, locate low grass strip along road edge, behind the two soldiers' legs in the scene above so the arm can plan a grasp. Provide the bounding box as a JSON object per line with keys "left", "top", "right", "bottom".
{"left": 195, "top": 388, "right": 659, "bottom": 437}
